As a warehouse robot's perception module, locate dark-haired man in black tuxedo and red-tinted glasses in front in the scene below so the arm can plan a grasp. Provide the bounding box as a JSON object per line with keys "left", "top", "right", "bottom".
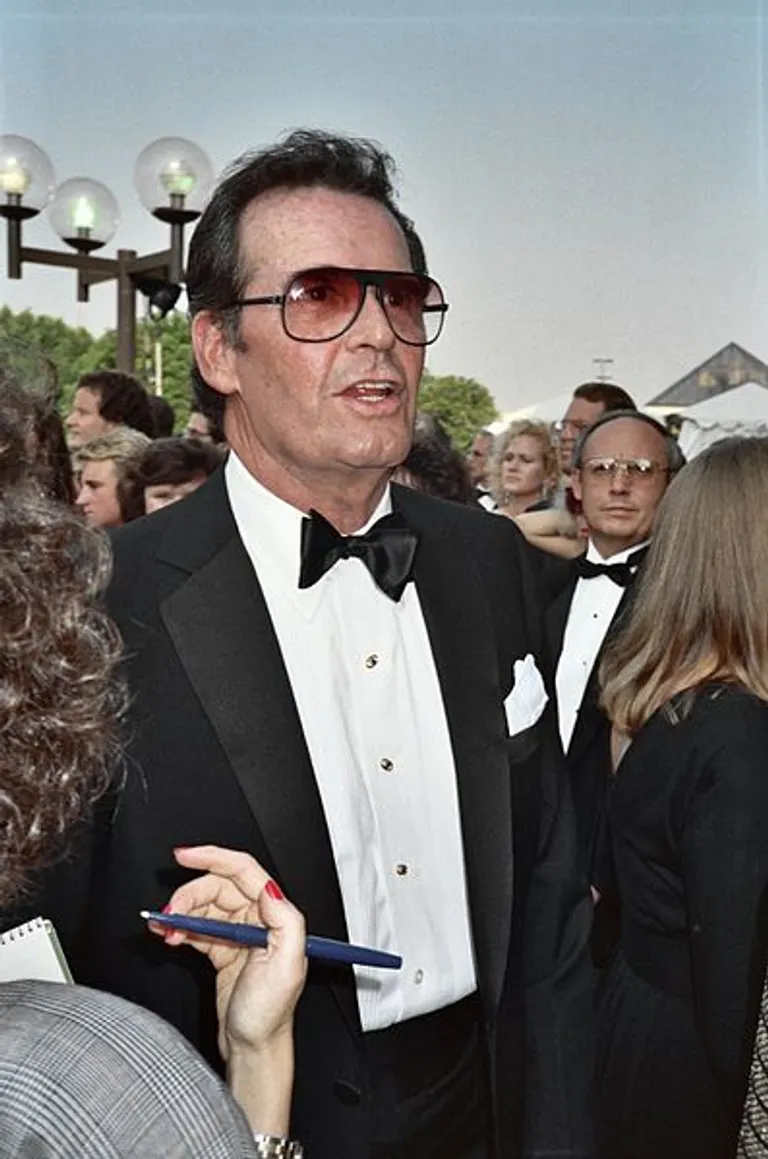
{"left": 20, "top": 131, "right": 591, "bottom": 1159}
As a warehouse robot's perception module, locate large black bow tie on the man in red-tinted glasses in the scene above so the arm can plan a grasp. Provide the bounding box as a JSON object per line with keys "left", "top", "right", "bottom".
{"left": 299, "top": 511, "right": 418, "bottom": 600}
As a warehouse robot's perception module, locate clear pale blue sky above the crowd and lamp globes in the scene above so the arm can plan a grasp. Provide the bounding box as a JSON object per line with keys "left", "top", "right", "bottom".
{"left": 0, "top": 0, "right": 768, "bottom": 409}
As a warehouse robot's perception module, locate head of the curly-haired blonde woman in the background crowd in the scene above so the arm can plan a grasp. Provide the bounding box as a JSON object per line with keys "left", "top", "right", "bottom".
{"left": 488, "top": 418, "right": 557, "bottom": 518}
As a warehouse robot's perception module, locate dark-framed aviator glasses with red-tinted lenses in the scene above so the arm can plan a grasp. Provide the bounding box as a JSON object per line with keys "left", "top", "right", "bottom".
{"left": 228, "top": 265, "right": 448, "bottom": 347}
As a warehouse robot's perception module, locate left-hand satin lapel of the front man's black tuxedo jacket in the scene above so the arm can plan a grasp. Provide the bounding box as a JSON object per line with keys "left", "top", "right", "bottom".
{"left": 161, "top": 489, "right": 359, "bottom": 1026}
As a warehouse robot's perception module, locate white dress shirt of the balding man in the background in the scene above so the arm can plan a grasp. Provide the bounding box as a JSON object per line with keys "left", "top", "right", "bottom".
{"left": 555, "top": 540, "right": 648, "bottom": 752}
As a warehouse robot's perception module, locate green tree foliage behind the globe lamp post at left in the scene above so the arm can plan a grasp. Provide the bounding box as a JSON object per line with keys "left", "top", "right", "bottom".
{"left": 0, "top": 306, "right": 192, "bottom": 430}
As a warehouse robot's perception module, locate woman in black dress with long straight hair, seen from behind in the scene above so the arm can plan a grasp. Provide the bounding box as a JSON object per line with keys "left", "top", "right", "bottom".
{"left": 598, "top": 439, "right": 768, "bottom": 1159}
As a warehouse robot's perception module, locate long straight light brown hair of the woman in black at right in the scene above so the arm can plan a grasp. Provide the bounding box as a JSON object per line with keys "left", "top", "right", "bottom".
{"left": 600, "top": 438, "right": 768, "bottom": 736}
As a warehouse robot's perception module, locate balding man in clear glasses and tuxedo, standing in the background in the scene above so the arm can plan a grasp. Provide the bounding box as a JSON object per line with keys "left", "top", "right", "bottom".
{"left": 544, "top": 410, "right": 682, "bottom": 868}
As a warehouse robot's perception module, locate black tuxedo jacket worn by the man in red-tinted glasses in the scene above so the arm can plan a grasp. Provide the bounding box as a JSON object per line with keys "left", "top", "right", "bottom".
{"left": 16, "top": 472, "right": 591, "bottom": 1159}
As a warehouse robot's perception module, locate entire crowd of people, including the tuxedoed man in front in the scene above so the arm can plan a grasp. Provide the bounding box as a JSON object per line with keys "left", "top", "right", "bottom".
{"left": 0, "top": 130, "right": 768, "bottom": 1159}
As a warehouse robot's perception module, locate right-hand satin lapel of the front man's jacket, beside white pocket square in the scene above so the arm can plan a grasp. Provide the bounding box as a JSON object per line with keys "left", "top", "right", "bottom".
{"left": 393, "top": 488, "right": 513, "bottom": 1012}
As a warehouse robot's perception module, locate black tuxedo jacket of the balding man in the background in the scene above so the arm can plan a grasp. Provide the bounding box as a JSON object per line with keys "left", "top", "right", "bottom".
{"left": 544, "top": 560, "right": 632, "bottom": 872}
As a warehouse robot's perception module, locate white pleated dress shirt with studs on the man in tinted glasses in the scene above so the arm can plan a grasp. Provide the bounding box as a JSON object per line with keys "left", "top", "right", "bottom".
{"left": 225, "top": 453, "right": 476, "bottom": 1030}
